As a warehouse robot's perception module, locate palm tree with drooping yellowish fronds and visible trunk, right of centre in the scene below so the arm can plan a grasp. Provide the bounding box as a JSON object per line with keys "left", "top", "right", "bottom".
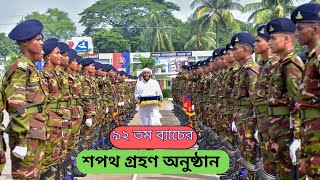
{"left": 190, "top": 0, "right": 243, "bottom": 47}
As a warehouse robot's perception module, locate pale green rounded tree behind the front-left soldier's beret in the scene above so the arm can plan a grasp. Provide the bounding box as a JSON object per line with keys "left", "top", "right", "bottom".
{"left": 24, "top": 8, "right": 76, "bottom": 41}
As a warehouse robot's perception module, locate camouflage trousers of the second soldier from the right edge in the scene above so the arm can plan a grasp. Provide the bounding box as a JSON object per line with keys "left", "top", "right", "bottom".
{"left": 269, "top": 116, "right": 291, "bottom": 179}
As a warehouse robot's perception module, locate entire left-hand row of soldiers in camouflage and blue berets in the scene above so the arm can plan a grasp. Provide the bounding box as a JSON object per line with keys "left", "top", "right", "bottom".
{"left": 0, "top": 19, "right": 137, "bottom": 179}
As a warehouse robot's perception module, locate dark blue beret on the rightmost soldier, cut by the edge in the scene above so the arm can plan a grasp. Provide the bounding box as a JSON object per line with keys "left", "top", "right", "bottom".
{"left": 291, "top": 3, "right": 320, "bottom": 24}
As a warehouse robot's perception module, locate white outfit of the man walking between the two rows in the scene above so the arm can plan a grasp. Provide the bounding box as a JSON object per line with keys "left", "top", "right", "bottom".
{"left": 134, "top": 79, "right": 163, "bottom": 126}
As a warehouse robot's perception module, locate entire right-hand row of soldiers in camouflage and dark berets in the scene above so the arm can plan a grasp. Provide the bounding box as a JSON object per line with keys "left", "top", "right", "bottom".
{"left": 173, "top": 3, "right": 320, "bottom": 179}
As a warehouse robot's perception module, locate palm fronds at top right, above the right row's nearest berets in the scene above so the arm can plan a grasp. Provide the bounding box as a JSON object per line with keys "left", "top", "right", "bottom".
{"left": 243, "top": 0, "right": 301, "bottom": 26}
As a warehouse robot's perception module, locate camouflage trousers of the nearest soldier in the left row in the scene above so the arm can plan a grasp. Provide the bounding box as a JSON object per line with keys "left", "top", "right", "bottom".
{"left": 9, "top": 135, "right": 45, "bottom": 179}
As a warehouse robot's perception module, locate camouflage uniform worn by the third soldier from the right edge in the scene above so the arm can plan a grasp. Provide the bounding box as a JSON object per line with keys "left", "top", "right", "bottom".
{"left": 254, "top": 56, "right": 279, "bottom": 174}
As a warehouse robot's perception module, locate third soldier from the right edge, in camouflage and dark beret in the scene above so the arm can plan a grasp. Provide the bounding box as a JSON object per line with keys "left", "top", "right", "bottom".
{"left": 253, "top": 25, "right": 279, "bottom": 175}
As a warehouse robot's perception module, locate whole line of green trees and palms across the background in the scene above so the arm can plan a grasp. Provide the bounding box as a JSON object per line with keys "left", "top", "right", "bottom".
{"left": 0, "top": 0, "right": 319, "bottom": 56}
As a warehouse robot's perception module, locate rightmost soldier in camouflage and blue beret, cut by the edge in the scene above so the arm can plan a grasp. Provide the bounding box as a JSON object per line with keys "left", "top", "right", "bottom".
{"left": 290, "top": 3, "right": 320, "bottom": 179}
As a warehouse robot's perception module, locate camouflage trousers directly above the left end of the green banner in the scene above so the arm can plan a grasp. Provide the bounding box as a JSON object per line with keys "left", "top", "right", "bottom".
{"left": 67, "top": 106, "right": 83, "bottom": 152}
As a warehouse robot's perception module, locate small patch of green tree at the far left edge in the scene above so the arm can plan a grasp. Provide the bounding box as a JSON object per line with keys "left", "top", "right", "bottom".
{"left": 0, "top": 33, "right": 19, "bottom": 56}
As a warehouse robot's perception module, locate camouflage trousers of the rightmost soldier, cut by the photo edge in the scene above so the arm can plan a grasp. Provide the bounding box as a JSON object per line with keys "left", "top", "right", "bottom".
{"left": 300, "top": 118, "right": 320, "bottom": 179}
